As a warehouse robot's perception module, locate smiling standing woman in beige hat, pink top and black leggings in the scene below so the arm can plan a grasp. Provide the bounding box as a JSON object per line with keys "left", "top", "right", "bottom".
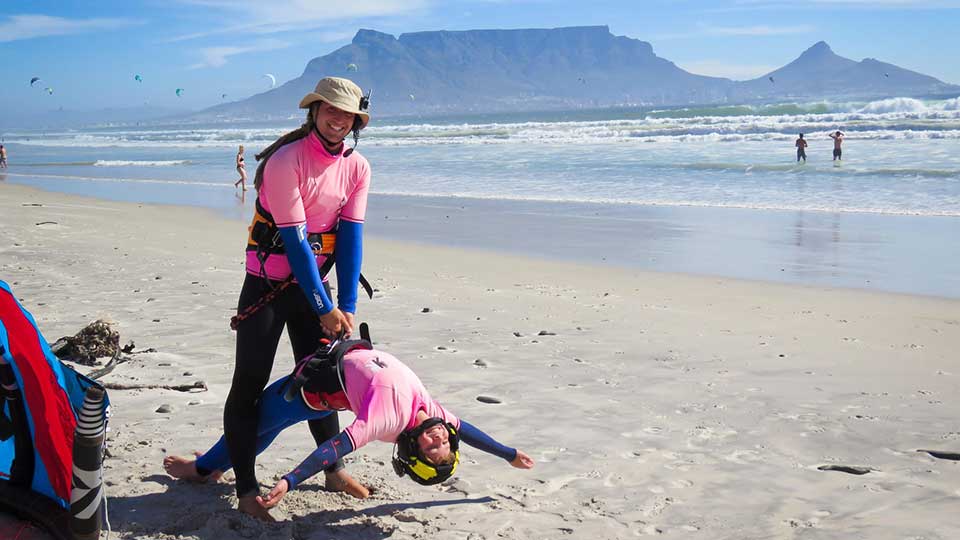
{"left": 223, "top": 77, "right": 372, "bottom": 518}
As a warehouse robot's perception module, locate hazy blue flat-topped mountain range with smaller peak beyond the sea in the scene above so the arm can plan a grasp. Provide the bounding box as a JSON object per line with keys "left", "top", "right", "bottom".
{"left": 194, "top": 26, "right": 960, "bottom": 119}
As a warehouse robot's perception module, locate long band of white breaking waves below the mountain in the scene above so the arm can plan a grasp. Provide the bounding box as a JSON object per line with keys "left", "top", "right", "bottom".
{"left": 8, "top": 97, "right": 960, "bottom": 150}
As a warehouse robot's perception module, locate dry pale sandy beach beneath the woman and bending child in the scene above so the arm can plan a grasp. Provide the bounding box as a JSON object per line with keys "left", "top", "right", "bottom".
{"left": 0, "top": 182, "right": 960, "bottom": 540}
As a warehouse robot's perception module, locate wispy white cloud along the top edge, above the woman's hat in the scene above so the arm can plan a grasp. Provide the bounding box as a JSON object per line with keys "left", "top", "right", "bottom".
{"left": 170, "top": 0, "right": 431, "bottom": 41}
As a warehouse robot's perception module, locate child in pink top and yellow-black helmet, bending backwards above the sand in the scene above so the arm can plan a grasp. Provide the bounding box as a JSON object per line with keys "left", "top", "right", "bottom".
{"left": 163, "top": 340, "right": 534, "bottom": 521}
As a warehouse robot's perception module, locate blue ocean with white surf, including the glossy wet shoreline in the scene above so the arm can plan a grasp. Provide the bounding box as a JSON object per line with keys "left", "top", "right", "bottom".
{"left": 0, "top": 98, "right": 960, "bottom": 297}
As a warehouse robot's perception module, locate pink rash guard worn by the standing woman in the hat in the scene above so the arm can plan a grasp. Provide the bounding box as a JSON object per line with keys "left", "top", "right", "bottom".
{"left": 247, "top": 132, "right": 370, "bottom": 280}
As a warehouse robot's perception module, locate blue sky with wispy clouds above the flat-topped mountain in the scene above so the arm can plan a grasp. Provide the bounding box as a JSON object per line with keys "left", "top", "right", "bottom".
{"left": 0, "top": 0, "right": 960, "bottom": 114}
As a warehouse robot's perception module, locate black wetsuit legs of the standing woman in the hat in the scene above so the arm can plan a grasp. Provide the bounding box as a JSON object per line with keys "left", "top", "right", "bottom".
{"left": 223, "top": 274, "right": 343, "bottom": 497}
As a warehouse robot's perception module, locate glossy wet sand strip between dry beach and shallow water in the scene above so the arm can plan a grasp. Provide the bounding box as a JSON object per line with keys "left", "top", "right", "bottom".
{"left": 3, "top": 175, "right": 960, "bottom": 298}
